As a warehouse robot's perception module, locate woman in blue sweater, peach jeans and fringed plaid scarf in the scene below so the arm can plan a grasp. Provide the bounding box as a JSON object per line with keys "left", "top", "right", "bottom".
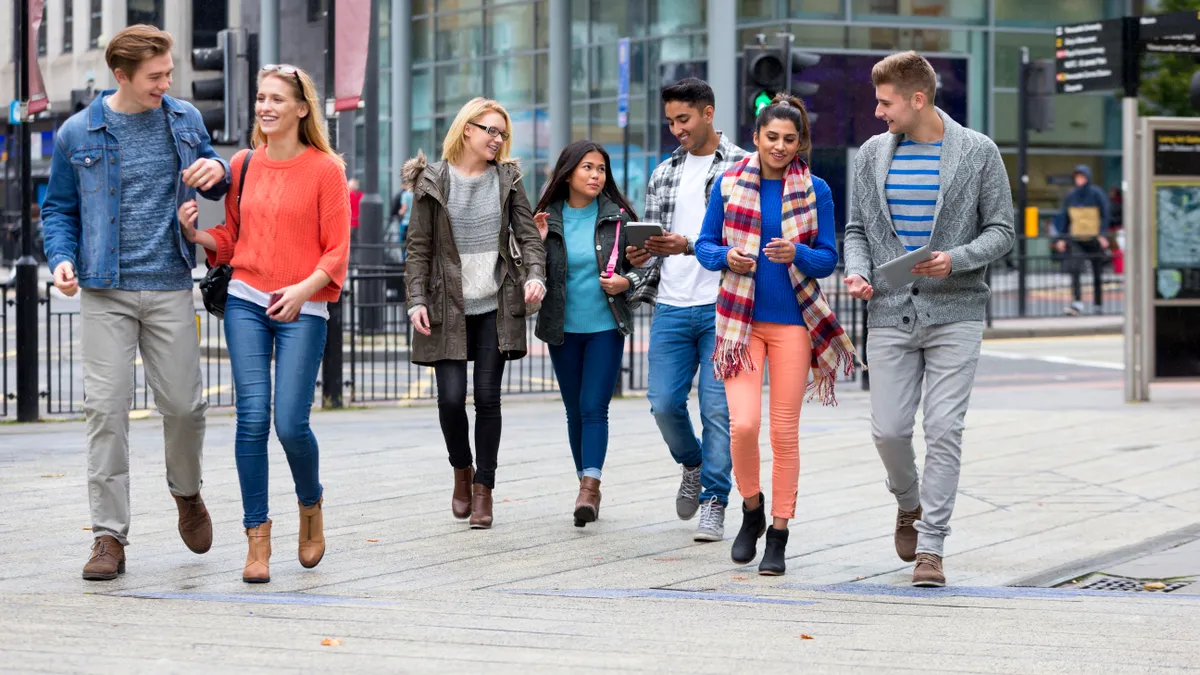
{"left": 696, "top": 95, "right": 854, "bottom": 575}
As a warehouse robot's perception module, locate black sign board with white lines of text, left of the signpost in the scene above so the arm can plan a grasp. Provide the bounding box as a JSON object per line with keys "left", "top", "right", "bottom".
{"left": 1055, "top": 19, "right": 1124, "bottom": 94}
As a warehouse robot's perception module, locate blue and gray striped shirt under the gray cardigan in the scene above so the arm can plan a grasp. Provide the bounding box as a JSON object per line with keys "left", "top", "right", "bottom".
{"left": 884, "top": 139, "right": 942, "bottom": 251}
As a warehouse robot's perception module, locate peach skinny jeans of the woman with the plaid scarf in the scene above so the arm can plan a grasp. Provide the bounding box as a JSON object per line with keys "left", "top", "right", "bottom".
{"left": 725, "top": 321, "right": 812, "bottom": 519}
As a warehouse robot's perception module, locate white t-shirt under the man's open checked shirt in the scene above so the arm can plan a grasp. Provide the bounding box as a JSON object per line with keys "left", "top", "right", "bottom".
{"left": 658, "top": 153, "right": 721, "bottom": 307}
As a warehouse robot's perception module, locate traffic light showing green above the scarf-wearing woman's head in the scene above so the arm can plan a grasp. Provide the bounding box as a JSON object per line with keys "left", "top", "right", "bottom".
{"left": 742, "top": 34, "right": 821, "bottom": 123}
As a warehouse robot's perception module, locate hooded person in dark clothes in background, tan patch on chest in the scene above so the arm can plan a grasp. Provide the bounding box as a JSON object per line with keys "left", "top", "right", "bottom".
{"left": 1054, "top": 165, "right": 1111, "bottom": 316}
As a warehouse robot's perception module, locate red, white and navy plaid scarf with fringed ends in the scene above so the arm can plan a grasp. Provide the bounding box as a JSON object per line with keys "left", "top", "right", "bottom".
{"left": 713, "top": 153, "right": 857, "bottom": 405}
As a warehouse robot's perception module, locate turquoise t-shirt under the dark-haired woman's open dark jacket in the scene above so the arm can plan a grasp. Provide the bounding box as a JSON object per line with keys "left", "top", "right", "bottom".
{"left": 563, "top": 199, "right": 617, "bottom": 333}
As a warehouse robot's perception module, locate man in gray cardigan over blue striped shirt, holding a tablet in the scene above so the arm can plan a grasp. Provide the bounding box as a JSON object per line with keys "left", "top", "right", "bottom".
{"left": 845, "top": 52, "right": 1015, "bottom": 586}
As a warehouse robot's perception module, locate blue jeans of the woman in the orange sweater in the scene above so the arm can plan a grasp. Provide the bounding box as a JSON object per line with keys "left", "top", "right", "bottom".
{"left": 224, "top": 295, "right": 325, "bottom": 528}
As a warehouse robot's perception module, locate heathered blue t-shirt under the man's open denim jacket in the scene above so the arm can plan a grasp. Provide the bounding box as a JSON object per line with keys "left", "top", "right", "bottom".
{"left": 104, "top": 100, "right": 193, "bottom": 291}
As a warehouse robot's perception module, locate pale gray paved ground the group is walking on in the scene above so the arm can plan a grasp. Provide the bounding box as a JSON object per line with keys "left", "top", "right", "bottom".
{"left": 0, "top": 336, "right": 1200, "bottom": 673}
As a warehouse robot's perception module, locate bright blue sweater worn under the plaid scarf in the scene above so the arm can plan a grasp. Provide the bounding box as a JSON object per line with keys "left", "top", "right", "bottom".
{"left": 696, "top": 175, "right": 838, "bottom": 325}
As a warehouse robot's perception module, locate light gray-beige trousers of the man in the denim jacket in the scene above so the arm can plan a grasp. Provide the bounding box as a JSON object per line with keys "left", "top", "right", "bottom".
{"left": 79, "top": 288, "right": 209, "bottom": 545}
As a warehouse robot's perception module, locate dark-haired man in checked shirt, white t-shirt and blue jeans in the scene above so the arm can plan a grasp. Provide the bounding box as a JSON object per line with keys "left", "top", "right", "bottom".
{"left": 628, "top": 78, "right": 746, "bottom": 542}
